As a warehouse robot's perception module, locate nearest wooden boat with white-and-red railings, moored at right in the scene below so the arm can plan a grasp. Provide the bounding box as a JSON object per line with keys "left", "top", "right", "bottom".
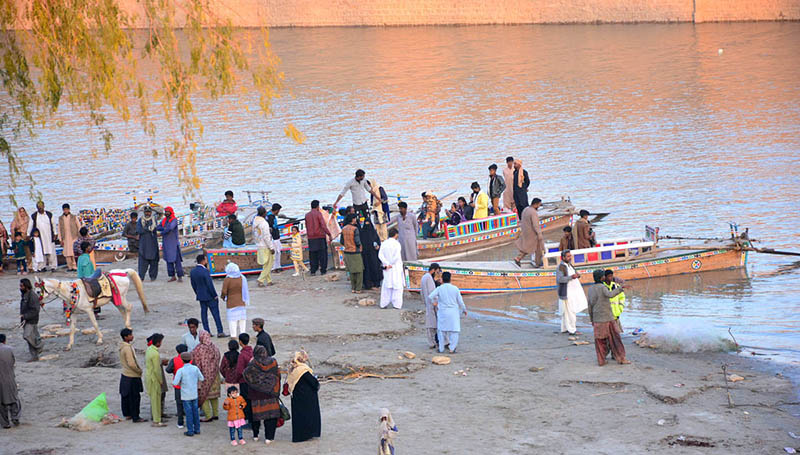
{"left": 405, "top": 227, "right": 750, "bottom": 294}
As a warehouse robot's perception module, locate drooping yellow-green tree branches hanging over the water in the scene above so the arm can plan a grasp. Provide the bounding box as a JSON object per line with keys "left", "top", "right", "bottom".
{"left": 0, "top": 0, "right": 290, "bottom": 205}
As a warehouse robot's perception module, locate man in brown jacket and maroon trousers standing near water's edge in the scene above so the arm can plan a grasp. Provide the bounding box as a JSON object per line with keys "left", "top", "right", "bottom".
{"left": 588, "top": 270, "right": 631, "bottom": 366}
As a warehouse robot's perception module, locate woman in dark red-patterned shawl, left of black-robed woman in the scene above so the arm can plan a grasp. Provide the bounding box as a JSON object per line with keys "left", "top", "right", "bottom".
{"left": 242, "top": 346, "right": 281, "bottom": 444}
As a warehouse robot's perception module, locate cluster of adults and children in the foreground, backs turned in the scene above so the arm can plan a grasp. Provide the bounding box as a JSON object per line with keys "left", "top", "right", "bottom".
{"left": 116, "top": 318, "right": 322, "bottom": 445}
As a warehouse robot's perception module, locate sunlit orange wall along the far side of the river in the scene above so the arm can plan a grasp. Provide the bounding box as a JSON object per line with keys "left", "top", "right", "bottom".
{"left": 16, "top": 0, "right": 800, "bottom": 27}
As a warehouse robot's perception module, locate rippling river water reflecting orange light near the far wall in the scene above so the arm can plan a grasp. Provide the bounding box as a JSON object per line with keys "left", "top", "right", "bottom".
{"left": 0, "top": 23, "right": 800, "bottom": 363}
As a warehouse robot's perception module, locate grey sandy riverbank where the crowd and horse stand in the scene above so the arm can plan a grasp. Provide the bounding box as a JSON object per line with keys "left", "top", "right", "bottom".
{"left": 0, "top": 261, "right": 800, "bottom": 454}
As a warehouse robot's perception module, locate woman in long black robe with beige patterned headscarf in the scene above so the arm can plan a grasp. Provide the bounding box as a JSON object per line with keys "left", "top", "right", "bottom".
{"left": 283, "top": 351, "right": 322, "bottom": 442}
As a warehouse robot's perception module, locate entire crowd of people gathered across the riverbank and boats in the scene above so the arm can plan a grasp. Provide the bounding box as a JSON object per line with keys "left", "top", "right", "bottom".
{"left": 0, "top": 167, "right": 630, "bottom": 453}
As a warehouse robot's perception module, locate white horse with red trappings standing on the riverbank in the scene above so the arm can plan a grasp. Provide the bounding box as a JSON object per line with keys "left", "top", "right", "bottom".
{"left": 34, "top": 269, "right": 150, "bottom": 351}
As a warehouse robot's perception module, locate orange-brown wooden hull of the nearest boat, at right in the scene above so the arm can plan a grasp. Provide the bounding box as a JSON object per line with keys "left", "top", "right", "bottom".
{"left": 405, "top": 249, "right": 747, "bottom": 294}
